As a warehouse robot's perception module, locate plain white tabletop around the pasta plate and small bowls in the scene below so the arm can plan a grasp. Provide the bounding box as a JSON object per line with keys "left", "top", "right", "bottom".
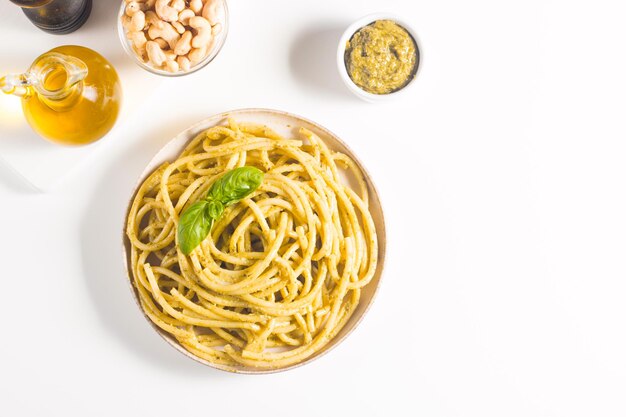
{"left": 0, "top": 0, "right": 626, "bottom": 417}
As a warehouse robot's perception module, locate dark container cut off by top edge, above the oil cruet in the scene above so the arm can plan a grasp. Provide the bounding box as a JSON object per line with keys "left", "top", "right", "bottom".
{"left": 11, "top": 0, "right": 92, "bottom": 35}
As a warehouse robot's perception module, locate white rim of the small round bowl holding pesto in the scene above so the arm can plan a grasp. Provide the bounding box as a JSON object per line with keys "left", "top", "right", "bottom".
{"left": 337, "top": 13, "right": 423, "bottom": 102}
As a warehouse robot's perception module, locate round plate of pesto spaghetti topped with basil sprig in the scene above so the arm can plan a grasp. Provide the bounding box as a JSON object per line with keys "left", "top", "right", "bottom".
{"left": 123, "top": 109, "right": 385, "bottom": 373}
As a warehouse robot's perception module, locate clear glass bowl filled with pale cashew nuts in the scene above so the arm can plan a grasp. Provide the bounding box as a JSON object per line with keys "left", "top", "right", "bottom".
{"left": 122, "top": 0, "right": 225, "bottom": 73}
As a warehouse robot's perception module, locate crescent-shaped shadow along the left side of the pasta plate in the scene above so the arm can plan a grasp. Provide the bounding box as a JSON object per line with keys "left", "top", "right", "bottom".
{"left": 80, "top": 114, "right": 228, "bottom": 377}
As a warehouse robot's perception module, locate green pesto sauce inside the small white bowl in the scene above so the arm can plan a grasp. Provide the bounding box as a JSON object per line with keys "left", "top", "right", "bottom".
{"left": 344, "top": 20, "right": 418, "bottom": 94}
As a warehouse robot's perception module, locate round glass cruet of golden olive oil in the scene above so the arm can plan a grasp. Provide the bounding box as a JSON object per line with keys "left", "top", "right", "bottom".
{"left": 0, "top": 46, "right": 122, "bottom": 145}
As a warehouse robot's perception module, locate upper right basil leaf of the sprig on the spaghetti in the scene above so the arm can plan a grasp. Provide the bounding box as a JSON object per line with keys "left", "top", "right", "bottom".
{"left": 207, "top": 166, "right": 263, "bottom": 207}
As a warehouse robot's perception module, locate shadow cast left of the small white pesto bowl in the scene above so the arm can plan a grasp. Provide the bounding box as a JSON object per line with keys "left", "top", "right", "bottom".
{"left": 289, "top": 23, "right": 353, "bottom": 99}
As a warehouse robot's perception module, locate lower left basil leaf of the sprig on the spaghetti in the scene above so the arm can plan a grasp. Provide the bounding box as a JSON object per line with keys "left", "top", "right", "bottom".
{"left": 178, "top": 200, "right": 213, "bottom": 255}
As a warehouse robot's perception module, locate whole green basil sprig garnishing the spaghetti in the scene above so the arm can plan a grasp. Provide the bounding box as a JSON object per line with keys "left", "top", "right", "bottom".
{"left": 178, "top": 166, "right": 263, "bottom": 255}
